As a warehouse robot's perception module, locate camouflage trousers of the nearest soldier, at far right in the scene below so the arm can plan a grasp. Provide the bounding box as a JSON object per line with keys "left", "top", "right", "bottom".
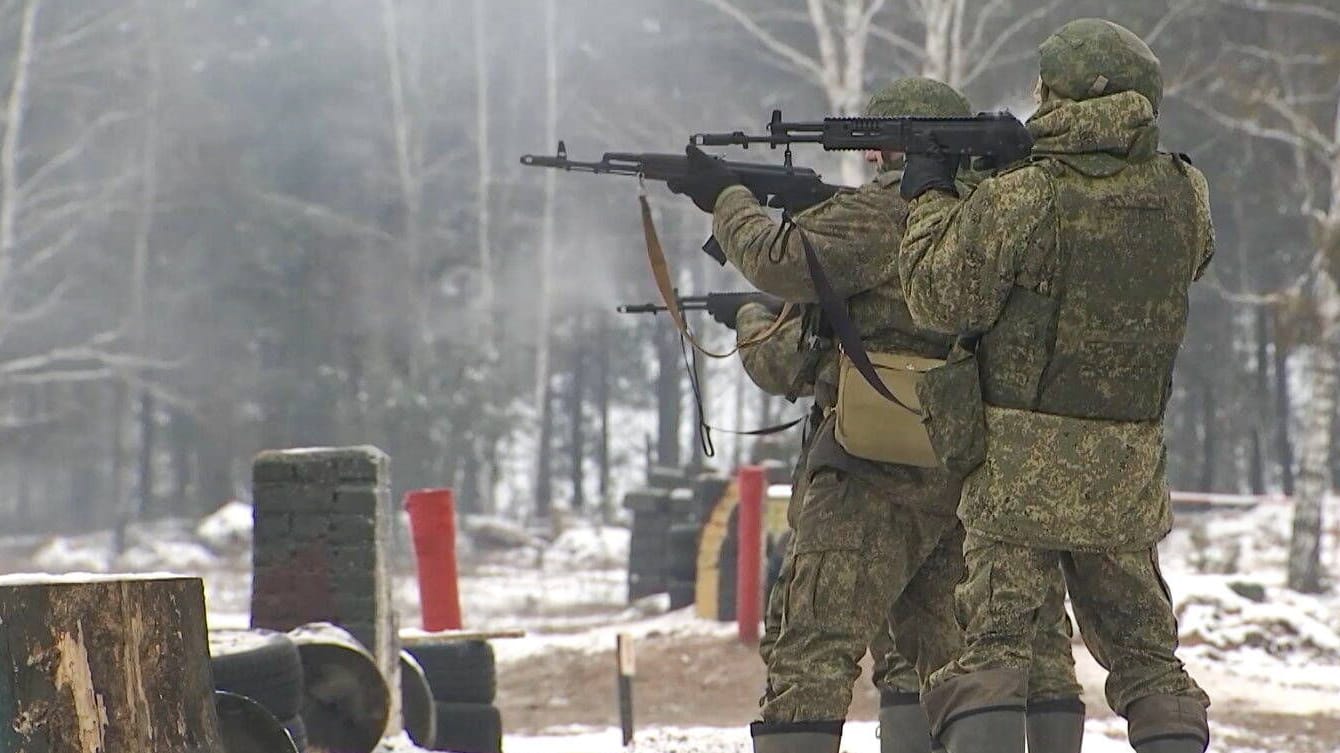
{"left": 923, "top": 532, "right": 1210, "bottom": 742}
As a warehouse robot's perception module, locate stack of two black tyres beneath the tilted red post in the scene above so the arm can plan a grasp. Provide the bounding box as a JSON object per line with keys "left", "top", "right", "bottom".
{"left": 406, "top": 640, "right": 503, "bottom": 753}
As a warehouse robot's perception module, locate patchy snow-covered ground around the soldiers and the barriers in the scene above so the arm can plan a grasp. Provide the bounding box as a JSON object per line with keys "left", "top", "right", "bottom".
{"left": 0, "top": 495, "right": 1340, "bottom": 753}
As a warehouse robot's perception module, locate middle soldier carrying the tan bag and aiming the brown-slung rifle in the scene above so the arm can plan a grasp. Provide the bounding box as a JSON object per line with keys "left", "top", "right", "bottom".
{"left": 670, "top": 79, "right": 1088, "bottom": 753}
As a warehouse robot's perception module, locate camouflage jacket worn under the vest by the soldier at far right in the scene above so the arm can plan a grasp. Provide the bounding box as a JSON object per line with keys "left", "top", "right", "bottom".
{"left": 899, "top": 92, "right": 1214, "bottom": 551}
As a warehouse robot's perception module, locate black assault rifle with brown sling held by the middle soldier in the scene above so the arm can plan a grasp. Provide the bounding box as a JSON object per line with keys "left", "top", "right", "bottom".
{"left": 521, "top": 141, "right": 843, "bottom": 265}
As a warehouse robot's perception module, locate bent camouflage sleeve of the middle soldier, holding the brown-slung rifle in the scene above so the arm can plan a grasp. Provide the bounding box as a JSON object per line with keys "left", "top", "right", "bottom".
{"left": 712, "top": 177, "right": 906, "bottom": 303}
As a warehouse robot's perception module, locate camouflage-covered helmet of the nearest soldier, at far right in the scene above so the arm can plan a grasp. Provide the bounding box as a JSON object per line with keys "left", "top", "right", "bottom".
{"left": 1039, "top": 19, "right": 1163, "bottom": 113}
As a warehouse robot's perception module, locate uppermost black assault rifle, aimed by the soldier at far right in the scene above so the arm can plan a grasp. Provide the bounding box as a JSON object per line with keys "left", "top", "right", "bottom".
{"left": 691, "top": 110, "right": 1033, "bottom": 167}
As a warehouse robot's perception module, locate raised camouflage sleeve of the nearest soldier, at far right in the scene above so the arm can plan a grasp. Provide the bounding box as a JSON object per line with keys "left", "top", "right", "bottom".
{"left": 898, "top": 167, "right": 1056, "bottom": 334}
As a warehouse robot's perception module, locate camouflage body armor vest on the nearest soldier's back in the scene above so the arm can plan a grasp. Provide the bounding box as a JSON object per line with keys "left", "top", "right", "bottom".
{"left": 977, "top": 154, "right": 1199, "bottom": 421}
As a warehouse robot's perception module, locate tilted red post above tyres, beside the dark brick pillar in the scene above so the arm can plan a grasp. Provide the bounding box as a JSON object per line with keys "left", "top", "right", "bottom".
{"left": 405, "top": 489, "right": 461, "bottom": 631}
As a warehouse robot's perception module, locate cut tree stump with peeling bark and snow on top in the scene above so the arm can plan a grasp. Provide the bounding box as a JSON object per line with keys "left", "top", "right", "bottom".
{"left": 0, "top": 575, "right": 224, "bottom": 753}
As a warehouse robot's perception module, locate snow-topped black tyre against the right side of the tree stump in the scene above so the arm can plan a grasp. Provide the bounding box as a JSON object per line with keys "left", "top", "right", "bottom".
{"left": 209, "top": 630, "right": 307, "bottom": 753}
